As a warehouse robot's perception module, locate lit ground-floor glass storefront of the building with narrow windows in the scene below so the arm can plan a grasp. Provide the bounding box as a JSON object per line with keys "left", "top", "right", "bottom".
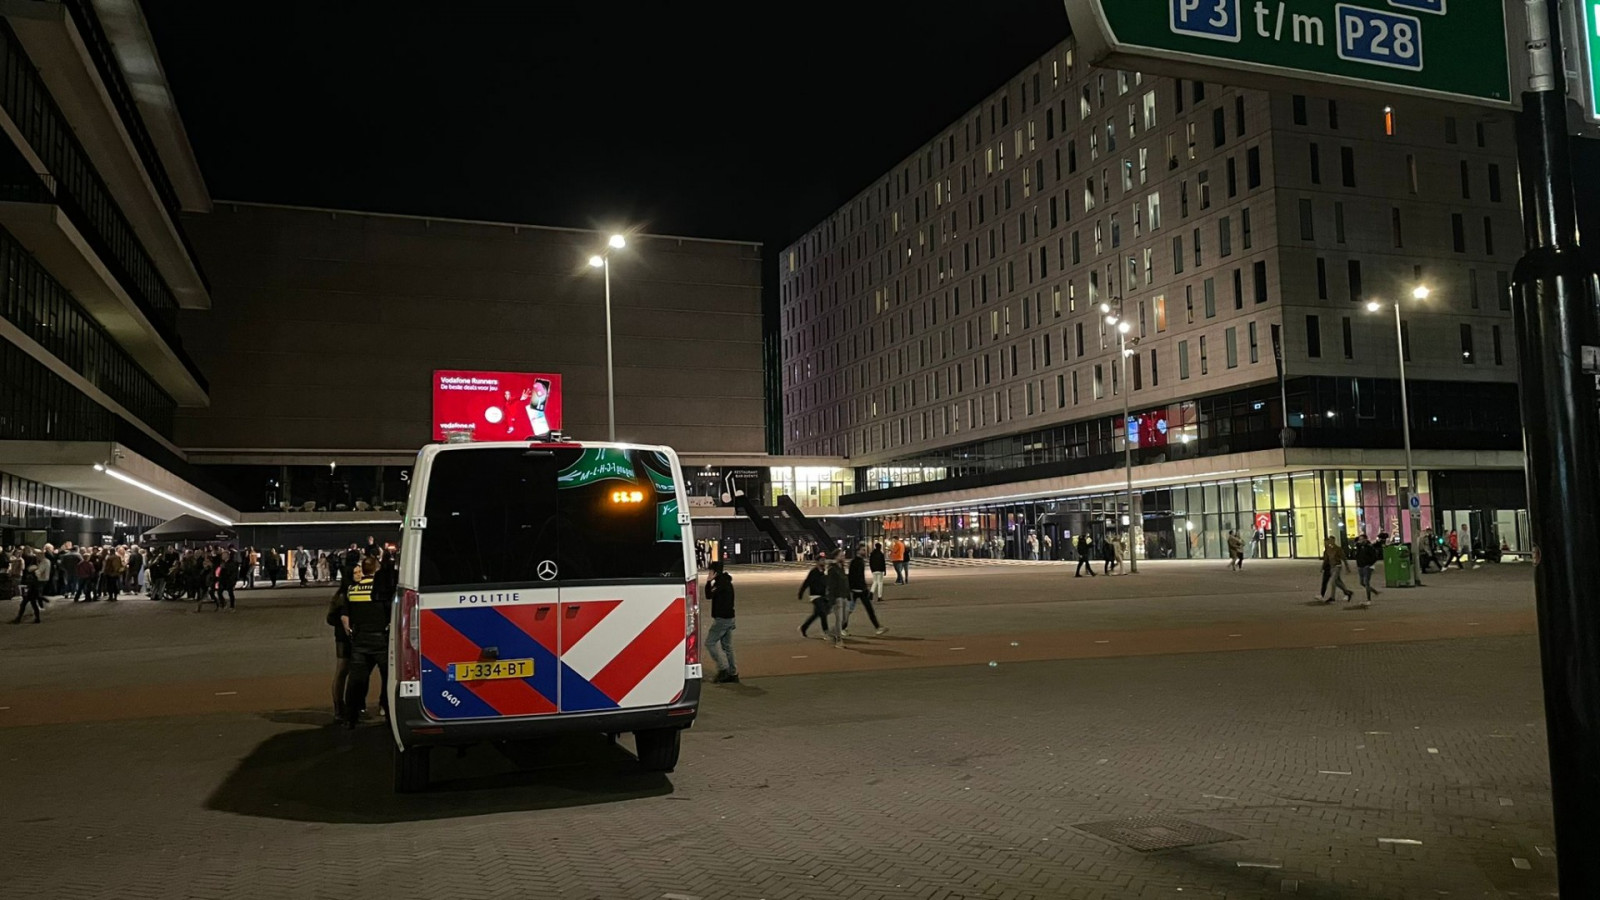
{"left": 862, "top": 469, "right": 1528, "bottom": 559}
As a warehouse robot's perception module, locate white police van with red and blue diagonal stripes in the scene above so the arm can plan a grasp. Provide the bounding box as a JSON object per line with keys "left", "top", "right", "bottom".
{"left": 387, "top": 442, "right": 701, "bottom": 793}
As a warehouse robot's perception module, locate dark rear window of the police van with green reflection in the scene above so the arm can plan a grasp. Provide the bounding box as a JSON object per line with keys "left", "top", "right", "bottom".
{"left": 419, "top": 447, "right": 685, "bottom": 588}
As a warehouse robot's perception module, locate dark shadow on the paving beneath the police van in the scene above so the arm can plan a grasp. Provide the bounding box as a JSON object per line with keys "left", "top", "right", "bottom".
{"left": 206, "top": 711, "right": 672, "bottom": 823}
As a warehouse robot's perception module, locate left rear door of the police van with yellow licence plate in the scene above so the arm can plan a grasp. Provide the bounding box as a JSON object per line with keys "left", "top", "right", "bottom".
{"left": 418, "top": 445, "right": 560, "bottom": 721}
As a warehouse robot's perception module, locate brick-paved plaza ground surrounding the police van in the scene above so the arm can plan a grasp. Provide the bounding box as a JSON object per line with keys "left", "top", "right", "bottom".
{"left": 0, "top": 562, "right": 1555, "bottom": 900}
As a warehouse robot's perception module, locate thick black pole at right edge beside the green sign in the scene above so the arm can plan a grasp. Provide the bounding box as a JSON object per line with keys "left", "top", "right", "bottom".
{"left": 1514, "top": 0, "right": 1600, "bottom": 897}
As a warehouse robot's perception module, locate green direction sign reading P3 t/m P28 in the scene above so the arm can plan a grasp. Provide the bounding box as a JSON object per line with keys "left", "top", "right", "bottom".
{"left": 1066, "top": 0, "right": 1510, "bottom": 107}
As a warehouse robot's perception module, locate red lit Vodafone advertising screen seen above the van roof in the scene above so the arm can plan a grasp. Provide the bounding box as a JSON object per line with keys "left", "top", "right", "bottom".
{"left": 434, "top": 370, "right": 562, "bottom": 440}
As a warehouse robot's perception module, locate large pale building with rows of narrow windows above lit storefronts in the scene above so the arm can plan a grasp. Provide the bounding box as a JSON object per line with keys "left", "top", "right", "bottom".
{"left": 779, "top": 40, "right": 1526, "bottom": 557}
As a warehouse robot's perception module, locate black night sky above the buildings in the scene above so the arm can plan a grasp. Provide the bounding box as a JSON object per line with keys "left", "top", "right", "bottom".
{"left": 144, "top": 0, "right": 1067, "bottom": 255}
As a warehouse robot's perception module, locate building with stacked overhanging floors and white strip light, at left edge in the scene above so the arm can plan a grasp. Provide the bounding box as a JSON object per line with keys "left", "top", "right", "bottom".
{"left": 0, "top": 0, "right": 226, "bottom": 544}
